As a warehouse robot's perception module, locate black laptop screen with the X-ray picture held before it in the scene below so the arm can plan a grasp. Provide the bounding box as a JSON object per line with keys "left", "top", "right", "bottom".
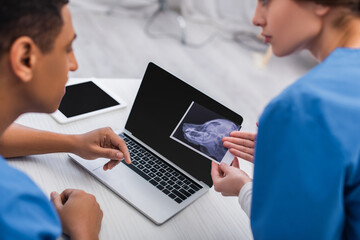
{"left": 125, "top": 63, "right": 243, "bottom": 186}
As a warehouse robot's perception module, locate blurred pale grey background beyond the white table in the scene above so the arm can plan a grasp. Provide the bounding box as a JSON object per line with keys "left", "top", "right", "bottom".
{"left": 66, "top": 0, "right": 316, "bottom": 131}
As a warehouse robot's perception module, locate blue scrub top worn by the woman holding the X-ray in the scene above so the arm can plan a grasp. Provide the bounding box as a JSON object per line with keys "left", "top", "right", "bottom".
{"left": 251, "top": 48, "right": 360, "bottom": 240}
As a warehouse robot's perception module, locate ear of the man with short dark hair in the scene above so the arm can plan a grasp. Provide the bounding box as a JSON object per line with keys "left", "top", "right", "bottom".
{"left": 10, "top": 37, "right": 39, "bottom": 82}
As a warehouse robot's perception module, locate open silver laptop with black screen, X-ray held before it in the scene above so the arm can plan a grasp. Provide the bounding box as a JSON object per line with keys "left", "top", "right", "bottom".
{"left": 70, "top": 63, "right": 243, "bottom": 225}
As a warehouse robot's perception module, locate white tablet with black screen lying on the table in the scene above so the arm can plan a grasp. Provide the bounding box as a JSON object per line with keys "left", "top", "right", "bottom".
{"left": 51, "top": 78, "right": 126, "bottom": 123}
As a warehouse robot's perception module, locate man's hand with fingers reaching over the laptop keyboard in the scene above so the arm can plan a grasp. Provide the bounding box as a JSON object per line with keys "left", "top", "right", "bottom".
{"left": 72, "top": 127, "right": 131, "bottom": 171}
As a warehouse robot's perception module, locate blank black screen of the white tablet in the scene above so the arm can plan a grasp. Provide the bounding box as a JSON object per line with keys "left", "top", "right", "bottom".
{"left": 59, "top": 81, "right": 120, "bottom": 118}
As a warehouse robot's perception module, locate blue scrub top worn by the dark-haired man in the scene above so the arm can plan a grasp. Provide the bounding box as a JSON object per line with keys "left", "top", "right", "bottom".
{"left": 0, "top": 157, "right": 61, "bottom": 240}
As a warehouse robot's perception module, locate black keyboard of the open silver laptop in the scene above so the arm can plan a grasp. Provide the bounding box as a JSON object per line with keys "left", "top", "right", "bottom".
{"left": 120, "top": 134, "right": 202, "bottom": 203}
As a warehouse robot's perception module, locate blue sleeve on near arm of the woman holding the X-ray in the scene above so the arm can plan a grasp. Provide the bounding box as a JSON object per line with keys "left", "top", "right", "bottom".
{"left": 251, "top": 92, "right": 345, "bottom": 240}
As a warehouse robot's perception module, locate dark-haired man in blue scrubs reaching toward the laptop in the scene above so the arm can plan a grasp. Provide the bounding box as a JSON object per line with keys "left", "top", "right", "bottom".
{"left": 0, "top": 0, "right": 130, "bottom": 239}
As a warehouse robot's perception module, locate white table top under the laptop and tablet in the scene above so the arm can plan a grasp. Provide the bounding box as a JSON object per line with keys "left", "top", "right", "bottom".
{"left": 9, "top": 79, "right": 252, "bottom": 240}
